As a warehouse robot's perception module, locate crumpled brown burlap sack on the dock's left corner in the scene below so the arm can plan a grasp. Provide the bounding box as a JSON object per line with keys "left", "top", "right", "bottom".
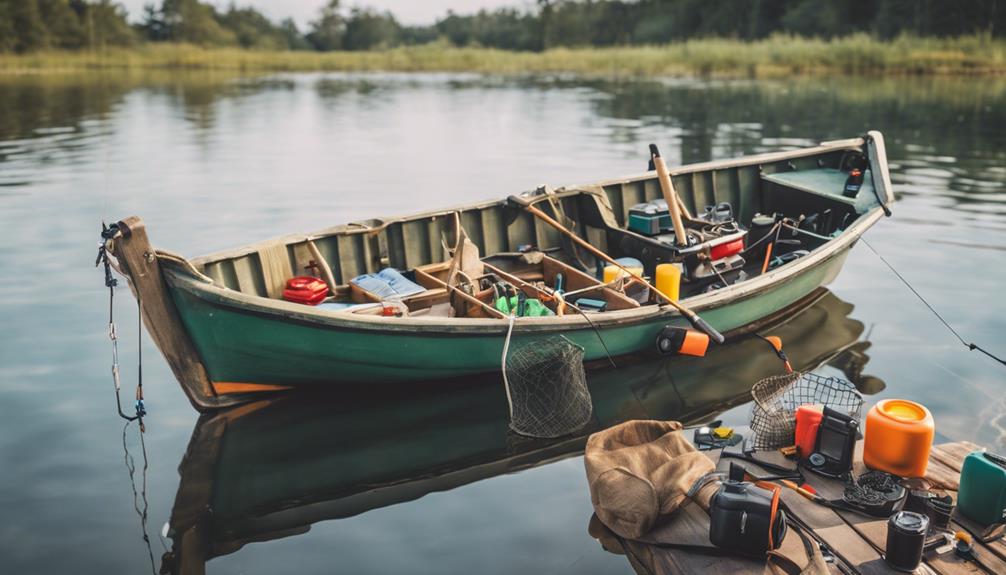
{"left": 583, "top": 420, "right": 715, "bottom": 539}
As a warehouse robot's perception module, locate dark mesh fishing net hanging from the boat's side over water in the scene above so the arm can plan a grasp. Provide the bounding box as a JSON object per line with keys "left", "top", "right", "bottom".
{"left": 503, "top": 324, "right": 594, "bottom": 437}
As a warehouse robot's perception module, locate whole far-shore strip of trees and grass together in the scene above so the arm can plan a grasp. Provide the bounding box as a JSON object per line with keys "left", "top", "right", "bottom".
{"left": 0, "top": 0, "right": 1006, "bottom": 77}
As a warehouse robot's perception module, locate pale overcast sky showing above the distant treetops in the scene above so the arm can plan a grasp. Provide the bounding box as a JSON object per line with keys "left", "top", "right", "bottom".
{"left": 119, "top": 0, "right": 531, "bottom": 26}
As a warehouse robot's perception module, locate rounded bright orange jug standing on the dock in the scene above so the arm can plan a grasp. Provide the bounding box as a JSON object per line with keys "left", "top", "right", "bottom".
{"left": 863, "top": 399, "right": 935, "bottom": 477}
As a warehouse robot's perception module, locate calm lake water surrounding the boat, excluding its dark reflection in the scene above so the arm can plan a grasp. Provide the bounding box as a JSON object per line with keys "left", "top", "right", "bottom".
{"left": 0, "top": 72, "right": 1006, "bottom": 574}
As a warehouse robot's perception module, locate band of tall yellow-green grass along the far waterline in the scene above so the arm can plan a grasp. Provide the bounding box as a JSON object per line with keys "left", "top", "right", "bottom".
{"left": 0, "top": 35, "right": 1006, "bottom": 76}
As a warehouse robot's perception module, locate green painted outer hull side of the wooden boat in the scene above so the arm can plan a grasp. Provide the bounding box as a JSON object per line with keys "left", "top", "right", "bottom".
{"left": 169, "top": 249, "right": 848, "bottom": 386}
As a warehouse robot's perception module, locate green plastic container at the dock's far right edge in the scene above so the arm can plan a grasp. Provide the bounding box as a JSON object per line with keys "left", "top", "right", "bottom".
{"left": 957, "top": 451, "right": 1006, "bottom": 526}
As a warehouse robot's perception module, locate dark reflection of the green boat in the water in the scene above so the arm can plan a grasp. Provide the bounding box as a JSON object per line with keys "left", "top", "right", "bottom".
{"left": 161, "top": 290, "right": 883, "bottom": 575}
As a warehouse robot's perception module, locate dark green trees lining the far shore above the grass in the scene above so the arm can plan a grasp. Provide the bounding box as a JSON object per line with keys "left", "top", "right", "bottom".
{"left": 0, "top": 0, "right": 1006, "bottom": 52}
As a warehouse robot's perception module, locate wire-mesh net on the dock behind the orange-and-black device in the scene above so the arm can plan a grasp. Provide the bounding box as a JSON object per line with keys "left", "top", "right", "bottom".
{"left": 751, "top": 372, "right": 863, "bottom": 449}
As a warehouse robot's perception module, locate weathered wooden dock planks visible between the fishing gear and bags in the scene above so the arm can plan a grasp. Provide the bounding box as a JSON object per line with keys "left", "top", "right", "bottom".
{"left": 591, "top": 441, "right": 1006, "bottom": 575}
